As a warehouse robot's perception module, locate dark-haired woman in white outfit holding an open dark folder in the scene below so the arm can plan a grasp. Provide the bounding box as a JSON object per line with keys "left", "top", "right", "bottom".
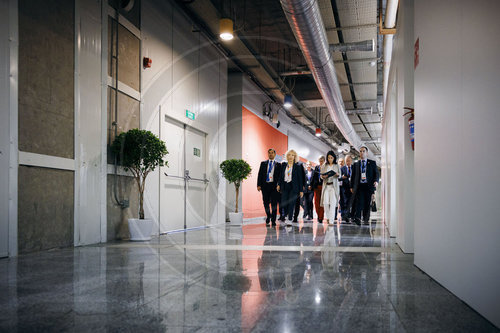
{"left": 320, "top": 150, "right": 340, "bottom": 224}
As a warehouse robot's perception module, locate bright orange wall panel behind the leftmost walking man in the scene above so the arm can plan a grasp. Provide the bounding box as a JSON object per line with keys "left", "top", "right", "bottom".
{"left": 241, "top": 107, "right": 288, "bottom": 218}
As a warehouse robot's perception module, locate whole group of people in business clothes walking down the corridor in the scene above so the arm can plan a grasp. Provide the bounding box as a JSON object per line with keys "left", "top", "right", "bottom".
{"left": 257, "top": 146, "right": 379, "bottom": 226}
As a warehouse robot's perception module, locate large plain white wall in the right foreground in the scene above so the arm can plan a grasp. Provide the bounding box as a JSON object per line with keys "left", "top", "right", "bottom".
{"left": 414, "top": 0, "right": 500, "bottom": 327}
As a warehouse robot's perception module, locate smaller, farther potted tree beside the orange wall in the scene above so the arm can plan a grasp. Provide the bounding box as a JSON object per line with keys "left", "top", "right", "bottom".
{"left": 220, "top": 159, "right": 252, "bottom": 225}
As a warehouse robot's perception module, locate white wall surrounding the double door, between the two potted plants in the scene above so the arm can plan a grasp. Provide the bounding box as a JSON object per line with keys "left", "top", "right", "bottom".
{"left": 141, "top": 0, "right": 227, "bottom": 230}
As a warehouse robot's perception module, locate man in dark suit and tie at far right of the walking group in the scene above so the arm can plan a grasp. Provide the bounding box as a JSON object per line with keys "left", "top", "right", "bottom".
{"left": 350, "top": 146, "right": 379, "bottom": 225}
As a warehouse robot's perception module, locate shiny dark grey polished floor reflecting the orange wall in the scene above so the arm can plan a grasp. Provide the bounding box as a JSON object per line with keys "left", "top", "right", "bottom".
{"left": 0, "top": 214, "right": 498, "bottom": 332}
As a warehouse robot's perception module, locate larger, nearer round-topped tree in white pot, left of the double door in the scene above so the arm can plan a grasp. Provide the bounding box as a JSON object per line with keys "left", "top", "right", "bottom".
{"left": 111, "top": 128, "right": 168, "bottom": 241}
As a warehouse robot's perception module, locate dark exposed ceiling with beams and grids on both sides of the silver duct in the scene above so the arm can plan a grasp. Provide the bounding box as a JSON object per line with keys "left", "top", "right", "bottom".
{"left": 178, "top": 0, "right": 382, "bottom": 155}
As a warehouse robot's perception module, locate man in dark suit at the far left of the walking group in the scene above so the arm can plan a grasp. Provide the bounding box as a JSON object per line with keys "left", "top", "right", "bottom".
{"left": 257, "top": 148, "right": 281, "bottom": 226}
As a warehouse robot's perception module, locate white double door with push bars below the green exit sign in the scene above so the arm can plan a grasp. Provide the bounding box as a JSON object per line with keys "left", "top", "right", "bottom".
{"left": 160, "top": 116, "right": 208, "bottom": 233}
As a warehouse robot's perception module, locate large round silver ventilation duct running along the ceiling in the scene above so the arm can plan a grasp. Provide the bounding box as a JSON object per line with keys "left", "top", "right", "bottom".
{"left": 281, "top": 0, "right": 362, "bottom": 150}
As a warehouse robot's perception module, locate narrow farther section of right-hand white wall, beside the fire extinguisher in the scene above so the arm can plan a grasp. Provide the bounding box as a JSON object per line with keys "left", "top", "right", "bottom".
{"left": 383, "top": 1, "right": 415, "bottom": 249}
